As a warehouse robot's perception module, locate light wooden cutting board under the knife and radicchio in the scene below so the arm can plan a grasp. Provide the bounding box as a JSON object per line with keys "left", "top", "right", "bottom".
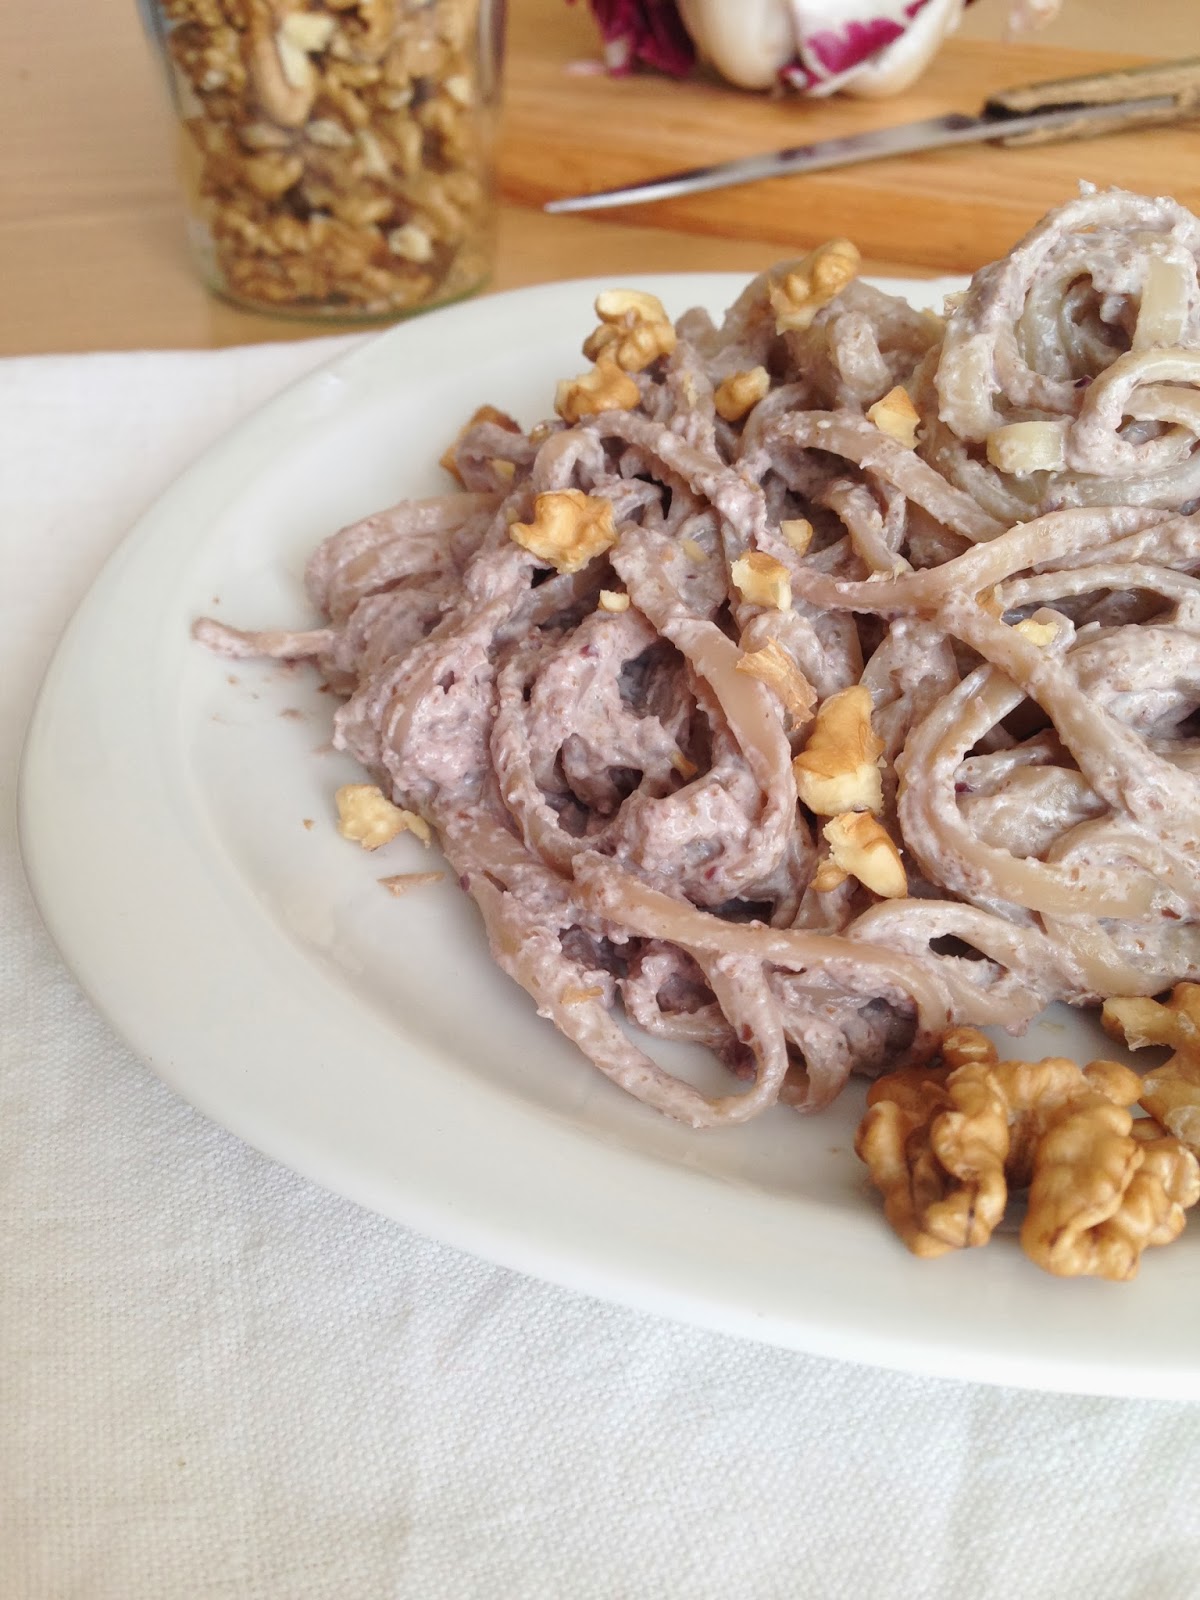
{"left": 499, "top": 0, "right": 1200, "bottom": 272}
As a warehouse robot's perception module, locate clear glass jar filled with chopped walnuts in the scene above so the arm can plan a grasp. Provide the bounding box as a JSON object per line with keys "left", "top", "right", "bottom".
{"left": 139, "top": 0, "right": 504, "bottom": 318}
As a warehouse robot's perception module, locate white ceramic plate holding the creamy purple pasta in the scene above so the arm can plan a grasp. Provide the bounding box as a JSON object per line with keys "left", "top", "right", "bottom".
{"left": 21, "top": 274, "right": 1200, "bottom": 1397}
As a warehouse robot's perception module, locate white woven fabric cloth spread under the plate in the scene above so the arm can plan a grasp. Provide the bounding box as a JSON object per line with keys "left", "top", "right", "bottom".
{"left": 0, "top": 341, "right": 1200, "bottom": 1600}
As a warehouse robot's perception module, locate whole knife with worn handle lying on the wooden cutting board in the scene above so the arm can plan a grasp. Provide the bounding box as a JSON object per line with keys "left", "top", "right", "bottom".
{"left": 546, "top": 58, "right": 1200, "bottom": 213}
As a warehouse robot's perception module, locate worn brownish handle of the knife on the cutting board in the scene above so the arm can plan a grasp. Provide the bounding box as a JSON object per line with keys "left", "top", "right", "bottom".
{"left": 984, "top": 56, "right": 1200, "bottom": 146}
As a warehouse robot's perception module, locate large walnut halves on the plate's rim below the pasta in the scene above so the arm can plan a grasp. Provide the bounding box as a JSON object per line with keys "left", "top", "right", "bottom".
{"left": 856, "top": 1011, "right": 1200, "bottom": 1280}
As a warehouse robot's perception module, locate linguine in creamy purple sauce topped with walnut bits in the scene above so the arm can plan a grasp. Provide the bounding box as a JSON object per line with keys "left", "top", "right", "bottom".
{"left": 197, "top": 192, "right": 1200, "bottom": 1126}
